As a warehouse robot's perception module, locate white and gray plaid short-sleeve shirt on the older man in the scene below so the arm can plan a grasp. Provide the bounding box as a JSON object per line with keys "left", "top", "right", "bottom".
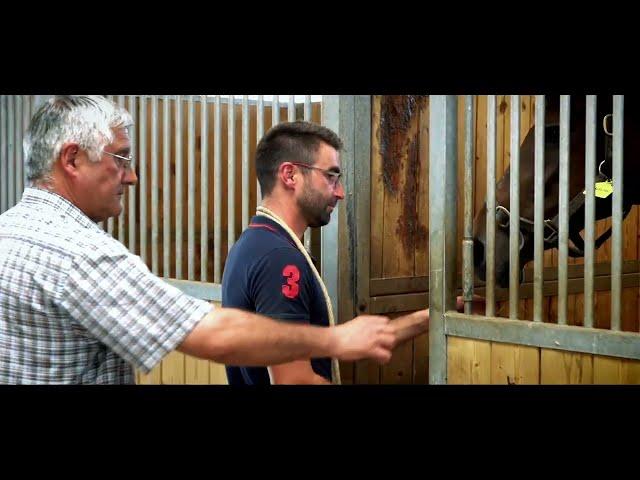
{"left": 0, "top": 188, "right": 213, "bottom": 384}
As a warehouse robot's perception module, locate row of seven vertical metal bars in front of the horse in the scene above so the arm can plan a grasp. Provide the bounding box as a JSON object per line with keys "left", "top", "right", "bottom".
{"left": 463, "top": 95, "right": 624, "bottom": 330}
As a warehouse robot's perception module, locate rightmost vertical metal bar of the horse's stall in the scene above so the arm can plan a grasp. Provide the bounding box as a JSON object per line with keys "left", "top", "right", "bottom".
{"left": 611, "top": 95, "right": 624, "bottom": 330}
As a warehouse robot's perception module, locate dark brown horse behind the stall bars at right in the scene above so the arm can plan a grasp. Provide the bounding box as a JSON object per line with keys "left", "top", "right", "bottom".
{"left": 474, "top": 95, "right": 640, "bottom": 288}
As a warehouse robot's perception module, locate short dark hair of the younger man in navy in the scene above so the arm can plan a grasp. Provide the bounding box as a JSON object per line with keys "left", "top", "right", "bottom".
{"left": 256, "top": 121, "right": 342, "bottom": 196}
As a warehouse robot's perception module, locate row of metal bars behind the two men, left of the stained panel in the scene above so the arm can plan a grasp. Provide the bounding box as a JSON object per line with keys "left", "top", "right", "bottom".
{"left": 0, "top": 95, "right": 312, "bottom": 283}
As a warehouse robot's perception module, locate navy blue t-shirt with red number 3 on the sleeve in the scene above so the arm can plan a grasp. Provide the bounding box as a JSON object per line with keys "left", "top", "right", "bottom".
{"left": 222, "top": 216, "right": 331, "bottom": 385}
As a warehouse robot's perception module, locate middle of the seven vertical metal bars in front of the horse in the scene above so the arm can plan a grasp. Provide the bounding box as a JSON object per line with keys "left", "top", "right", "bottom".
{"left": 533, "top": 95, "right": 545, "bottom": 322}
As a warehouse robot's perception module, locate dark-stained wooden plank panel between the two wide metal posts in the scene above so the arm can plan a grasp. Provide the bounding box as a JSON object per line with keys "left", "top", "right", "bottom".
{"left": 354, "top": 96, "right": 429, "bottom": 384}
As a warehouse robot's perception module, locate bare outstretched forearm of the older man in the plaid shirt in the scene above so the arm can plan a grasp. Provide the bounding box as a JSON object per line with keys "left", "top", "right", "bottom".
{"left": 178, "top": 308, "right": 335, "bottom": 366}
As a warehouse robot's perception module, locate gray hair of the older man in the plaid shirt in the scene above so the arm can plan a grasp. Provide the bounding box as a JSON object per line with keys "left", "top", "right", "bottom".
{"left": 23, "top": 95, "right": 133, "bottom": 182}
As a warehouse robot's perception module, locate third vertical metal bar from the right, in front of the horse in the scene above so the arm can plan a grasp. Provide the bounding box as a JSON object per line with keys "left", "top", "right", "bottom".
{"left": 558, "top": 95, "right": 571, "bottom": 325}
